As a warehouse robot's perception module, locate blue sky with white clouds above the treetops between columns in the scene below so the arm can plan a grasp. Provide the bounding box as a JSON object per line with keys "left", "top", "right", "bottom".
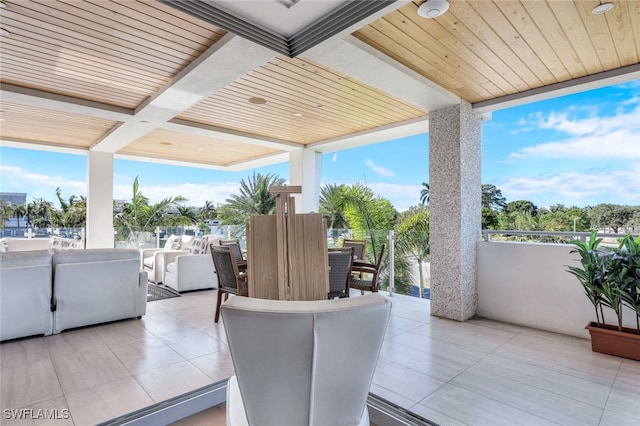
{"left": 0, "top": 80, "right": 640, "bottom": 210}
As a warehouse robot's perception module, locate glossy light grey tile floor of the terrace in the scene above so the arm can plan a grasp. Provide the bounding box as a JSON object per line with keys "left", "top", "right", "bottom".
{"left": 0, "top": 291, "right": 640, "bottom": 426}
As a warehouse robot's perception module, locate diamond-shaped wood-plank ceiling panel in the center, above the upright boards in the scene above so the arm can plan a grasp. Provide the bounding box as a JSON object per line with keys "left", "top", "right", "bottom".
{"left": 178, "top": 56, "right": 427, "bottom": 145}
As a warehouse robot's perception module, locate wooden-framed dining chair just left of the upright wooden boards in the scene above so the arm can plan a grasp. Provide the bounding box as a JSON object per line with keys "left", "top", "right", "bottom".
{"left": 209, "top": 244, "right": 249, "bottom": 322}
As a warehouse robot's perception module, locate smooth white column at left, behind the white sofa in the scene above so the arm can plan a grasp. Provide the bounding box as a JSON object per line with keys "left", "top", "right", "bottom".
{"left": 86, "top": 151, "right": 114, "bottom": 248}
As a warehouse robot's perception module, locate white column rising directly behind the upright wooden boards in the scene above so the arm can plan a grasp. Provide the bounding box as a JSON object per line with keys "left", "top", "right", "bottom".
{"left": 289, "top": 148, "right": 322, "bottom": 213}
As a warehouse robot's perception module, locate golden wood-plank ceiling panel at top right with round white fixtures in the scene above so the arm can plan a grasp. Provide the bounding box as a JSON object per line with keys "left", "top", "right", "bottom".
{"left": 354, "top": 0, "right": 640, "bottom": 103}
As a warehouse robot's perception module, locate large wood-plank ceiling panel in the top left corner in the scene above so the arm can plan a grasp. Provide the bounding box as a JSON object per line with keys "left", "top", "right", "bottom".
{"left": 0, "top": 0, "right": 224, "bottom": 109}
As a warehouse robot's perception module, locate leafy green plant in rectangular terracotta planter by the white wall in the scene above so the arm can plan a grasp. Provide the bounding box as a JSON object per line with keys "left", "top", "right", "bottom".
{"left": 567, "top": 232, "right": 640, "bottom": 360}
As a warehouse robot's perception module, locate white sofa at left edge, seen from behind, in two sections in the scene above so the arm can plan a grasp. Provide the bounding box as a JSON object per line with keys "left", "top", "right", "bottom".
{"left": 0, "top": 249, "right": 147, "bottom": 340}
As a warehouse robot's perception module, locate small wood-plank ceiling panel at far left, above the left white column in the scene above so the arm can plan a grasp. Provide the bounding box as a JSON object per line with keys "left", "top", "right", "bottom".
{"left": 0, "top": 102, "right": 117, "bottom": 149}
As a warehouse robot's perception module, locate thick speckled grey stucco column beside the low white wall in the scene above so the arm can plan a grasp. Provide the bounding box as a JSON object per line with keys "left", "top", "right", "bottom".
{"left": 429, "top": 101, "right": 482, "bottom": 321}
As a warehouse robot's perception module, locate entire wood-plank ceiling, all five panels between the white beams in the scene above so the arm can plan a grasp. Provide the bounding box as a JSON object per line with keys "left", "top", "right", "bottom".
{"left": 0, "top": 0, "right": 640, "bottom": 166}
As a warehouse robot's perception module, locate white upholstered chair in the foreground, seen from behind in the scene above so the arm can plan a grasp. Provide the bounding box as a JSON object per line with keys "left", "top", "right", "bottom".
{"left": 221, "top": 294, "right": 391, "bottom": 426}
